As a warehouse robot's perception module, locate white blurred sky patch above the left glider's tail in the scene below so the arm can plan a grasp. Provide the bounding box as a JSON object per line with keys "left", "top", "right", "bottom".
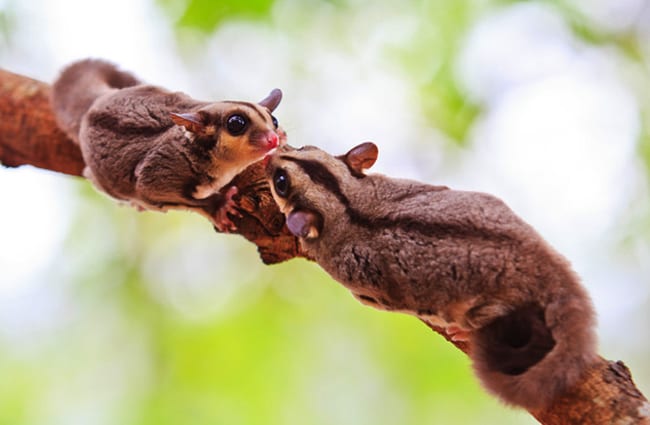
{"left": 3, "top": 0, "right": 187, "bottom": 89}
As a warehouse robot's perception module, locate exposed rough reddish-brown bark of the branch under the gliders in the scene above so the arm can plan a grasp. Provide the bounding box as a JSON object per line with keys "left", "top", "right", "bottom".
{"left": 0, "top": 70, "right": 650, "bottom": 425}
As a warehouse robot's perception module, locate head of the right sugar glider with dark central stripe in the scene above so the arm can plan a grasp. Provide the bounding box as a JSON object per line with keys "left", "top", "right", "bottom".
{"left": 266, "top": 142, "right": 378, "bottom": 240}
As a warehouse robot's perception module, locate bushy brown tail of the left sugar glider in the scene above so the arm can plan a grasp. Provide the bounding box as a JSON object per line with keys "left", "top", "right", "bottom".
{"left": 52, "top": 59, "right": 140, "bottom": 143}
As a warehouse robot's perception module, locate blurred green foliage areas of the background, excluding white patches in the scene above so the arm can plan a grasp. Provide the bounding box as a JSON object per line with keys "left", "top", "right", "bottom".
{"left": 0, "top": 0, "right": 650, "bottom": 425}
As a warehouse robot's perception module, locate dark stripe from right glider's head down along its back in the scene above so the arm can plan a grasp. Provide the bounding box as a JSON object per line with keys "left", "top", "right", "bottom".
{"left": 281, "top": 155, "right": 509, "bottom": 240}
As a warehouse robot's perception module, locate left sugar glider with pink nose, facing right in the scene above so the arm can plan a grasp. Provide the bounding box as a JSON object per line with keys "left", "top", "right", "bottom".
{"left": 52, "top": 59, "right": 284, "bottom": 225}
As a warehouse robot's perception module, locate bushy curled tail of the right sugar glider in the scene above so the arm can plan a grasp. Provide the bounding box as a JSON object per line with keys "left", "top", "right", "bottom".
{"left": 472, "top": 294, "right": 597, "bottom": 409}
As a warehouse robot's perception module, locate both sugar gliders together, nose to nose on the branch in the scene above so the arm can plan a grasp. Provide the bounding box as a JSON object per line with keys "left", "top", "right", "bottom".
{"left": 52, "top": 60, "right": 597, "bottom": 409}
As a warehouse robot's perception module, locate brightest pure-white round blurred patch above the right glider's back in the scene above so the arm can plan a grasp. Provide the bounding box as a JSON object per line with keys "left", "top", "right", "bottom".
{"left": 466, "top": 70, "right": 639, "bottom": 237}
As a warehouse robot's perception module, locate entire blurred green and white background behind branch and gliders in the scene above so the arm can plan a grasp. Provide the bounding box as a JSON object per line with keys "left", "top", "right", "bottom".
{"left": 0, "top": 0, "right": 650, "bottom": 425}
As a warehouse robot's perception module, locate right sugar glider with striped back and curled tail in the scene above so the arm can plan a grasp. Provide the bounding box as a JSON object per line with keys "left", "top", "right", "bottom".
{"left": 267, "top": 144, "right": 596, "bottom": 409}
